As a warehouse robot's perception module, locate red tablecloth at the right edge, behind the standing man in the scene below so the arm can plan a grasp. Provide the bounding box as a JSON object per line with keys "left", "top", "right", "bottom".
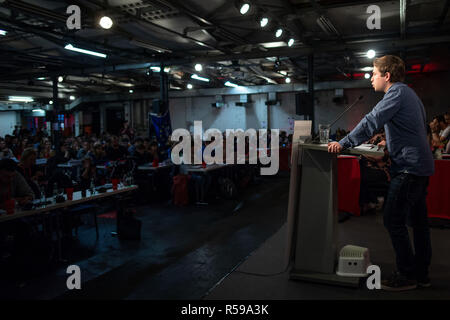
{"left": 427, "top": 160, "right": 450, "bottom": 219}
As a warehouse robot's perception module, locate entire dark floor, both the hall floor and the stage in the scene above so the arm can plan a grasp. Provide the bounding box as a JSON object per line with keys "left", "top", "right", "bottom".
{"left": 0, "top": 175, "right": 450, "bottom": 300}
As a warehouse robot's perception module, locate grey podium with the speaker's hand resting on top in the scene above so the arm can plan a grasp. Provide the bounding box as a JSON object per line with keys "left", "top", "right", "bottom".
{"left": 286, "top": 142, "right": 384, "bottom": 287}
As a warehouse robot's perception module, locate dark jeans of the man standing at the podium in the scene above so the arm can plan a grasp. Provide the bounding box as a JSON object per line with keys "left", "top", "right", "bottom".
{"left": 384, "top": 173, "right": 431, "bottom": 280}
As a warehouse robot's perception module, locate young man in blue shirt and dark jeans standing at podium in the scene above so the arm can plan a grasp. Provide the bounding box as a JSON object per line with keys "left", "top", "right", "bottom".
{"left": 328, "top": 55, "right": 434, "bottom": 291}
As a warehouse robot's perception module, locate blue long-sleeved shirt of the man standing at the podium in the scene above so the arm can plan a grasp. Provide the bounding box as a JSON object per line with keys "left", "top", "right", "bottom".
{"left": 339, "top": 82, "right": 434, "bottom": 176}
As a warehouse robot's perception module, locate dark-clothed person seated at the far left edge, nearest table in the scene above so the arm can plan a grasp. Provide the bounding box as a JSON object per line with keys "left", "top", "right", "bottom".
{"left": 0, "top": 159, "right": 34, "bottom": 208}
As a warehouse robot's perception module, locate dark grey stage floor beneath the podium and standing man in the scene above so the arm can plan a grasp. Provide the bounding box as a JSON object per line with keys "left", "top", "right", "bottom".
{"left": 206, "top": 212, "right": 450, "bottom": 300}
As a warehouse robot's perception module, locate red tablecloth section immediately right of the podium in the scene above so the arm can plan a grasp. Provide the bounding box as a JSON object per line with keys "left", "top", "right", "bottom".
{"left": 338, "top": 156, "right": 361, "bottom": 216}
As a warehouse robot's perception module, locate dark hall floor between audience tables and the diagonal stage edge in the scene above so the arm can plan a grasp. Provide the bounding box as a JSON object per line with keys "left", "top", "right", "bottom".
{"left": 0, "top": 175, "right": 289, "bottom": 299}
